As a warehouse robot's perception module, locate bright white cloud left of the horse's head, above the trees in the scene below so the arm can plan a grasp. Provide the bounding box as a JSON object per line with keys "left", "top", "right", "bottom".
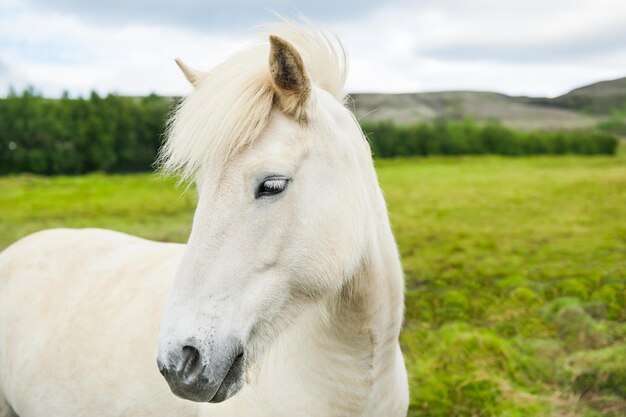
{"left": 0, "top": 3, "right": 249, "bottom": 95}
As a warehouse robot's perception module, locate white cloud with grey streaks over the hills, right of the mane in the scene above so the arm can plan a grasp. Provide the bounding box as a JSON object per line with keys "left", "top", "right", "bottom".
{"left": 326, "top": 0, "right": 626, "bottom": 96}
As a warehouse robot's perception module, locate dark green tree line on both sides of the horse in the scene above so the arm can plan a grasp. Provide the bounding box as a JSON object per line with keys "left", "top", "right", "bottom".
{"left": 0, "top": 89, "right": 618, "bottom": 175}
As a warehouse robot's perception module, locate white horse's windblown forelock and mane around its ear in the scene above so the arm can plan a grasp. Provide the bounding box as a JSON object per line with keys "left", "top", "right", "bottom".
{"left": 159, "top": 22, "right": 347, "bottom": 180}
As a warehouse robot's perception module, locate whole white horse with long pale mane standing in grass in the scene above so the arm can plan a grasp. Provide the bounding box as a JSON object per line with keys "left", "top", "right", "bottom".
{"left": 0, "top": 23, "right": 408, "bottom": 417}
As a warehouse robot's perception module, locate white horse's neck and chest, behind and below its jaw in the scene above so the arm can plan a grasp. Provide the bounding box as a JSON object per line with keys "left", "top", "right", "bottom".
{"left": 251, "top": 184, "right": 406, "bottom": 416}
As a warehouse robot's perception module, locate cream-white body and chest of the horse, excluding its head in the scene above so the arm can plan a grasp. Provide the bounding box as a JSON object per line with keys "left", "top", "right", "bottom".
{"left": 0, "top": 229, "right": 406, "bottom": 417}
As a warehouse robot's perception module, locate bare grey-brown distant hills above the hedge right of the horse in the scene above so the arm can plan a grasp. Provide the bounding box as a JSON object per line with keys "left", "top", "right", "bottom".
{"left": 351, "top": 78, "right": 626, "bottom": 130}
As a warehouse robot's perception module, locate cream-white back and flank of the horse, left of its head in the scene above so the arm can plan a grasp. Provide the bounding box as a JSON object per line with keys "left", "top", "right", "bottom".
{"left": 0, "top": 229, "right": 193, "bottom": 417}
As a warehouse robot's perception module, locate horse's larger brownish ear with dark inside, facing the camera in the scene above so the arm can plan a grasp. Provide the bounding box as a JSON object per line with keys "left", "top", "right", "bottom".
{"left": 270, "top": 35, "right": 311, "bottom": 123}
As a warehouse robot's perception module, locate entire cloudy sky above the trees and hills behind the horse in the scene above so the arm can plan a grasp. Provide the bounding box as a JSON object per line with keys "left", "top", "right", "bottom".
{"left": 0, "top": 0, "right": 626, "bottom": 96}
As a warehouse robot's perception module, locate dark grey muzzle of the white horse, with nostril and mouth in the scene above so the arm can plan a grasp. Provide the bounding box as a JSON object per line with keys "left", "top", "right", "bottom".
{"left": 157, "top": 341, "right": 244, "bottom": 403}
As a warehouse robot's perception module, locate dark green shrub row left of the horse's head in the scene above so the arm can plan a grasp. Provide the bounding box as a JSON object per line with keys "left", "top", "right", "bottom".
{"left": 0, "top": 91, "right": 171, "bottom": 175}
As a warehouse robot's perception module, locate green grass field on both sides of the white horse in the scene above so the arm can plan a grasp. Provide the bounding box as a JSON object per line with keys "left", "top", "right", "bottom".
{"left": 0, "top": 155, "right": 626, "bottom": 417}
